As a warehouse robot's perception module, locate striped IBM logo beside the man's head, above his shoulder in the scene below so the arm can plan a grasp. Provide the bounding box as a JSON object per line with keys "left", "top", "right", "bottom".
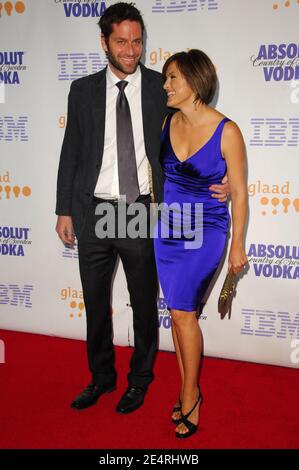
{"left": 57, "top": 52, "right": 107, "bottom": 80}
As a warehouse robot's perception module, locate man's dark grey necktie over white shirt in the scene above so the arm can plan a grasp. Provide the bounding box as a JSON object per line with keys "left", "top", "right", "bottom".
{"left": 116, "top": 80, "right": 140, "bottom": 204}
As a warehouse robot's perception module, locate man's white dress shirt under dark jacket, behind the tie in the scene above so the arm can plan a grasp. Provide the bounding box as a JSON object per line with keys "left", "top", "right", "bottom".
{"left": 94, "top": 65, "right": 150, "bottom": 199}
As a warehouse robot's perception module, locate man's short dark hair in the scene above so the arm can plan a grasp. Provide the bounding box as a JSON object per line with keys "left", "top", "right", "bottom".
{"left": 98, "top": 2, "right": 144, "bottom": 41}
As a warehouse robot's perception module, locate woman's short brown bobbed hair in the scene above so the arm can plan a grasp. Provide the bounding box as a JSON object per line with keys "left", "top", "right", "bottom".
{"left": 162, "top": 49, "right": 217, "bottom": 104}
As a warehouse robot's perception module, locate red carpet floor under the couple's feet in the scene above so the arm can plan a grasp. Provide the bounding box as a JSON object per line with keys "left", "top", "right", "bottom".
{"left": 0, "top": 330, "right": 299, "bottom": 449}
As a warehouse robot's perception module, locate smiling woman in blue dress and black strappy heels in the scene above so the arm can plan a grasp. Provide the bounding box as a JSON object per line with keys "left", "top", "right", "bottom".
{"left": 154, "top": 49, "right": 247, "bottom": 438}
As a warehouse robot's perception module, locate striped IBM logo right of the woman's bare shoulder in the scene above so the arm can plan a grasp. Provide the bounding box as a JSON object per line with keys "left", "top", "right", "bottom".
{"left": 250, "top": 118, "right": 299, "bottom": 147}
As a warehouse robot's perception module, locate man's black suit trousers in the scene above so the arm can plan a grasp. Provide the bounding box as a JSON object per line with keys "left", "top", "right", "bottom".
{"left": 78, "top": 198, "right": 158, "bottom": 388}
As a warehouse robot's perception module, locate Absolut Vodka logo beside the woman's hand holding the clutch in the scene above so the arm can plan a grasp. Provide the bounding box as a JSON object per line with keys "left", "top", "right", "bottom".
{"left": 247, "top": 244, "right": 299, "bottom": 279}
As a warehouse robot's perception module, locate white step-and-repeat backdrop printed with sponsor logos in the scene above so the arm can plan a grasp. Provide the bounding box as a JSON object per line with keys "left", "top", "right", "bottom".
{"left": 0, "top": 0, "right": 299, "bottom": 367}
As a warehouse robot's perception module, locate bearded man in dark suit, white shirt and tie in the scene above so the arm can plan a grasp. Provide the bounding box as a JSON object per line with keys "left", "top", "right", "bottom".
{"left": 56, "top": 2, "right": 226, "bottom": 413}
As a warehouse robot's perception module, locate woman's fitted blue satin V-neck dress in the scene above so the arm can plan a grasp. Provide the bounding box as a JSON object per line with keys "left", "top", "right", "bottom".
{"left": 154, "top": 115, "right": 230, "bottom": 311}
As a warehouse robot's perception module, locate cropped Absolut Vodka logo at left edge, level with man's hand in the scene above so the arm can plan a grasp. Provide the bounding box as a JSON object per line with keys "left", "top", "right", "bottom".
{"left": 0, "top": 227, "right": 31, "bottom": 256}
